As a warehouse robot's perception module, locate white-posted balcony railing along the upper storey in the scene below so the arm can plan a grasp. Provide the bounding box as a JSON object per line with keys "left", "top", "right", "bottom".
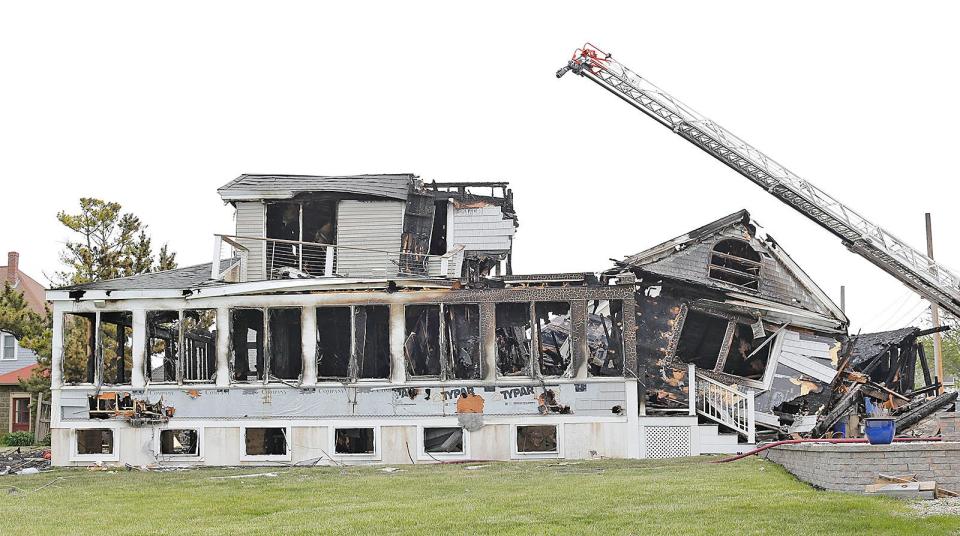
{"left": 211, "top": 234, "right": 463, "bottom": 281}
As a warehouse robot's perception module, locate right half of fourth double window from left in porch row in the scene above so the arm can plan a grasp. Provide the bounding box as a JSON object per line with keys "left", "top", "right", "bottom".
{"left": 353, "top": 305, "right": 390, "bottom": 379}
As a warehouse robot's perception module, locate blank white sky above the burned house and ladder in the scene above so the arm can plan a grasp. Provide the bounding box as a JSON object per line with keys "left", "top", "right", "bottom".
{"left": 0, "top": 1, "right": 960, "bottom": 332}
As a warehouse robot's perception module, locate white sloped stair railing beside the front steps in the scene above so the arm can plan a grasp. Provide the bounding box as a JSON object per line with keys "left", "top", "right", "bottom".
{"left": 689, "top": 365, "right": 756, "bottom": 443}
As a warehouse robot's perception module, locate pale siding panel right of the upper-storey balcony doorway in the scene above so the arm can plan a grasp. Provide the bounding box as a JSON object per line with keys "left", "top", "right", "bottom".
{"left": 337, "top": 200, "right": 403, "bottom": 277}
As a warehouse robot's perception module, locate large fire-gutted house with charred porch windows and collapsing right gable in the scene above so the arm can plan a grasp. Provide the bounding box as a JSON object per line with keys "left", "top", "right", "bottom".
{"left": 48, "top": 174, "right": 936, "bottom": 465}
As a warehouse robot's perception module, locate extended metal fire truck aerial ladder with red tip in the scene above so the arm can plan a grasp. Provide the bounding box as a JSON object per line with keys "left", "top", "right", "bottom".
{"left": 557, "top": 43, "right": 960, "bottom": 318}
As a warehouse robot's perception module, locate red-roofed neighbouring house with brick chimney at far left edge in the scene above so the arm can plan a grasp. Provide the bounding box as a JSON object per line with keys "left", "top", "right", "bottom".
{"left": 0, "top": 251, "right": 46, "bottom": 432}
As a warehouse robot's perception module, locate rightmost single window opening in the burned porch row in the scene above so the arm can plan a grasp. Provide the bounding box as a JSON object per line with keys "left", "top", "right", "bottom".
{"left": 587, "top": 300, "right": 623, "bottom": 376}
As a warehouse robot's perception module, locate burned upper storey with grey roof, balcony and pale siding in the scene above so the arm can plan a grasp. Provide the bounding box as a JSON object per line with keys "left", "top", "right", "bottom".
{"left": 214, "top": 173, "right": 516, "bottom": 281}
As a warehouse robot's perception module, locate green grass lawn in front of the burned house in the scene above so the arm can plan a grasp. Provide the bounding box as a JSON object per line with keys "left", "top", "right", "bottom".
{"left": 0, "top": 457, "right": 960, "bottom": 536}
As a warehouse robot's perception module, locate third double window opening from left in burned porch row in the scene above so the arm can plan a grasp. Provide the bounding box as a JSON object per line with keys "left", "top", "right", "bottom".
{"left": 230, "top": 307, "right": 303, "bottom": 383}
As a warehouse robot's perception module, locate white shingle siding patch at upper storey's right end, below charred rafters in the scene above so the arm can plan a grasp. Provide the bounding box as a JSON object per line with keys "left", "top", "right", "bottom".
{"left": 447, "top": 204, "right": 514, "bottom": 251}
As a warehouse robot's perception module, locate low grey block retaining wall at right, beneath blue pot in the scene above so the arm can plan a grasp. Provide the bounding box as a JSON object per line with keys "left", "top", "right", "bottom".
{"left": 762, "top": 442, "right": 960, "bottom": 493}
